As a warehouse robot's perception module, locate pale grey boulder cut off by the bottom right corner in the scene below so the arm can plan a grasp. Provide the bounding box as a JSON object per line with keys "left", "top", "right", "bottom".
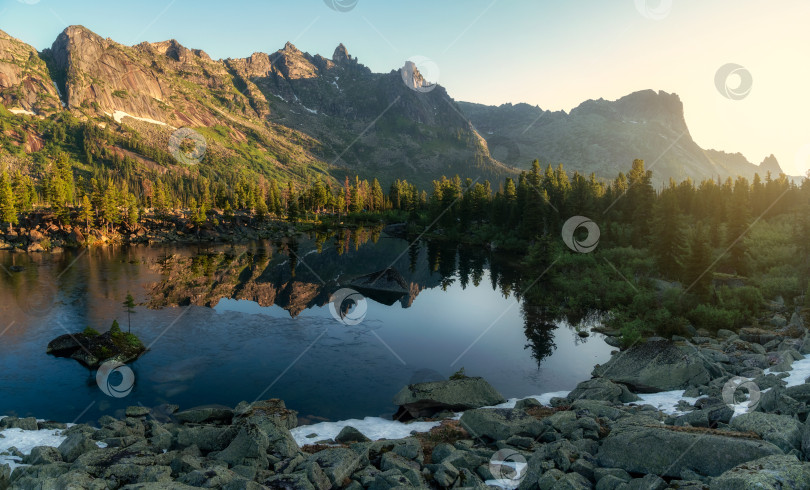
{"left": 710, "top": 455, "right": 810, "bottom": 490}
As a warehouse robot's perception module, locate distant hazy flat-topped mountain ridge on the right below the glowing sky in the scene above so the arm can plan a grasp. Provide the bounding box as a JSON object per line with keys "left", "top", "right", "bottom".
{"left": 460, "top": 90, "right": 792, "bottom": 183}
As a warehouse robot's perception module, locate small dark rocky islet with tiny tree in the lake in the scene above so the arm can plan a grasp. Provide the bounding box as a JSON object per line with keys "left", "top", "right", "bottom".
{"left": 46, "top": 321, "right": 146, "bottom": 369}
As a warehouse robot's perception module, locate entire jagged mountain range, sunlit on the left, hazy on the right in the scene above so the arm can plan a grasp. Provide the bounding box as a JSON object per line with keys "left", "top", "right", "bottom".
{"left": 0, "top": 26, "right": 781, "bottom": 188}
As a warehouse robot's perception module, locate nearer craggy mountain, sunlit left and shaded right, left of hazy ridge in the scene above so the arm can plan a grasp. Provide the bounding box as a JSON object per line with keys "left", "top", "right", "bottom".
{"left": 0, "top": 26, "right": 504, "bottom": 187}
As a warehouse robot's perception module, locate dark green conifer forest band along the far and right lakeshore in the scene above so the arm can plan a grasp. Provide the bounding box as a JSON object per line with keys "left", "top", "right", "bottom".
{"left": 0, "top": 108, "right": 810, "bottom": 345}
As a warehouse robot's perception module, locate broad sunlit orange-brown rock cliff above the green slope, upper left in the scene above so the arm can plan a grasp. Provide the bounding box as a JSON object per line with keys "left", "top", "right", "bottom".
{"left": 44, "top": 26, "right": 255, "bottom": 127}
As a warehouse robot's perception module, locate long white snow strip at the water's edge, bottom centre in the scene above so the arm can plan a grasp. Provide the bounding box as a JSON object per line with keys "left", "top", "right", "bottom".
{"left": 290, "top": 417, "right": 440, "bottom": 446}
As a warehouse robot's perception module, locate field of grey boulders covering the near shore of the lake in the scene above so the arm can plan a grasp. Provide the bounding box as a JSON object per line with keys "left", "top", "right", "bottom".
{"left": 0, "top": 314, "right": 810, "bottom": 490}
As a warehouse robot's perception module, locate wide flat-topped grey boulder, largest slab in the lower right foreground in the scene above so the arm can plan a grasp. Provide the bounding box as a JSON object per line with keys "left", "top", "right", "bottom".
{"left": 596, "top": 425, "right": 783, "bottom": 478}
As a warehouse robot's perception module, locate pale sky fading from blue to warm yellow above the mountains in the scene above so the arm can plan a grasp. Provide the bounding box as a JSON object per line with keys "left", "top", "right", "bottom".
{"left": 0, "top": 0, "right": 810, "bottom": 175}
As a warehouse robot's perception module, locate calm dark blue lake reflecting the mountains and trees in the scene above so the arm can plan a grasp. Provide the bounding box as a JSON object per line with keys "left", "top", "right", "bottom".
{"left": 0, "top": 232, "right": 611, "bottom": 423}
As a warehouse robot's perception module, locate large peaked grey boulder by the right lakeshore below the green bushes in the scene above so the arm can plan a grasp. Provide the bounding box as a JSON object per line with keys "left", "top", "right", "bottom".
{"left": 592, "top": 340, "right": 722, "bottom": 393}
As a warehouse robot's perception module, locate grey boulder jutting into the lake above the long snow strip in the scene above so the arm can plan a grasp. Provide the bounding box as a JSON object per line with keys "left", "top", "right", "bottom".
{"left": 394, "top": 378, "right": 506, "bottom": 418}
